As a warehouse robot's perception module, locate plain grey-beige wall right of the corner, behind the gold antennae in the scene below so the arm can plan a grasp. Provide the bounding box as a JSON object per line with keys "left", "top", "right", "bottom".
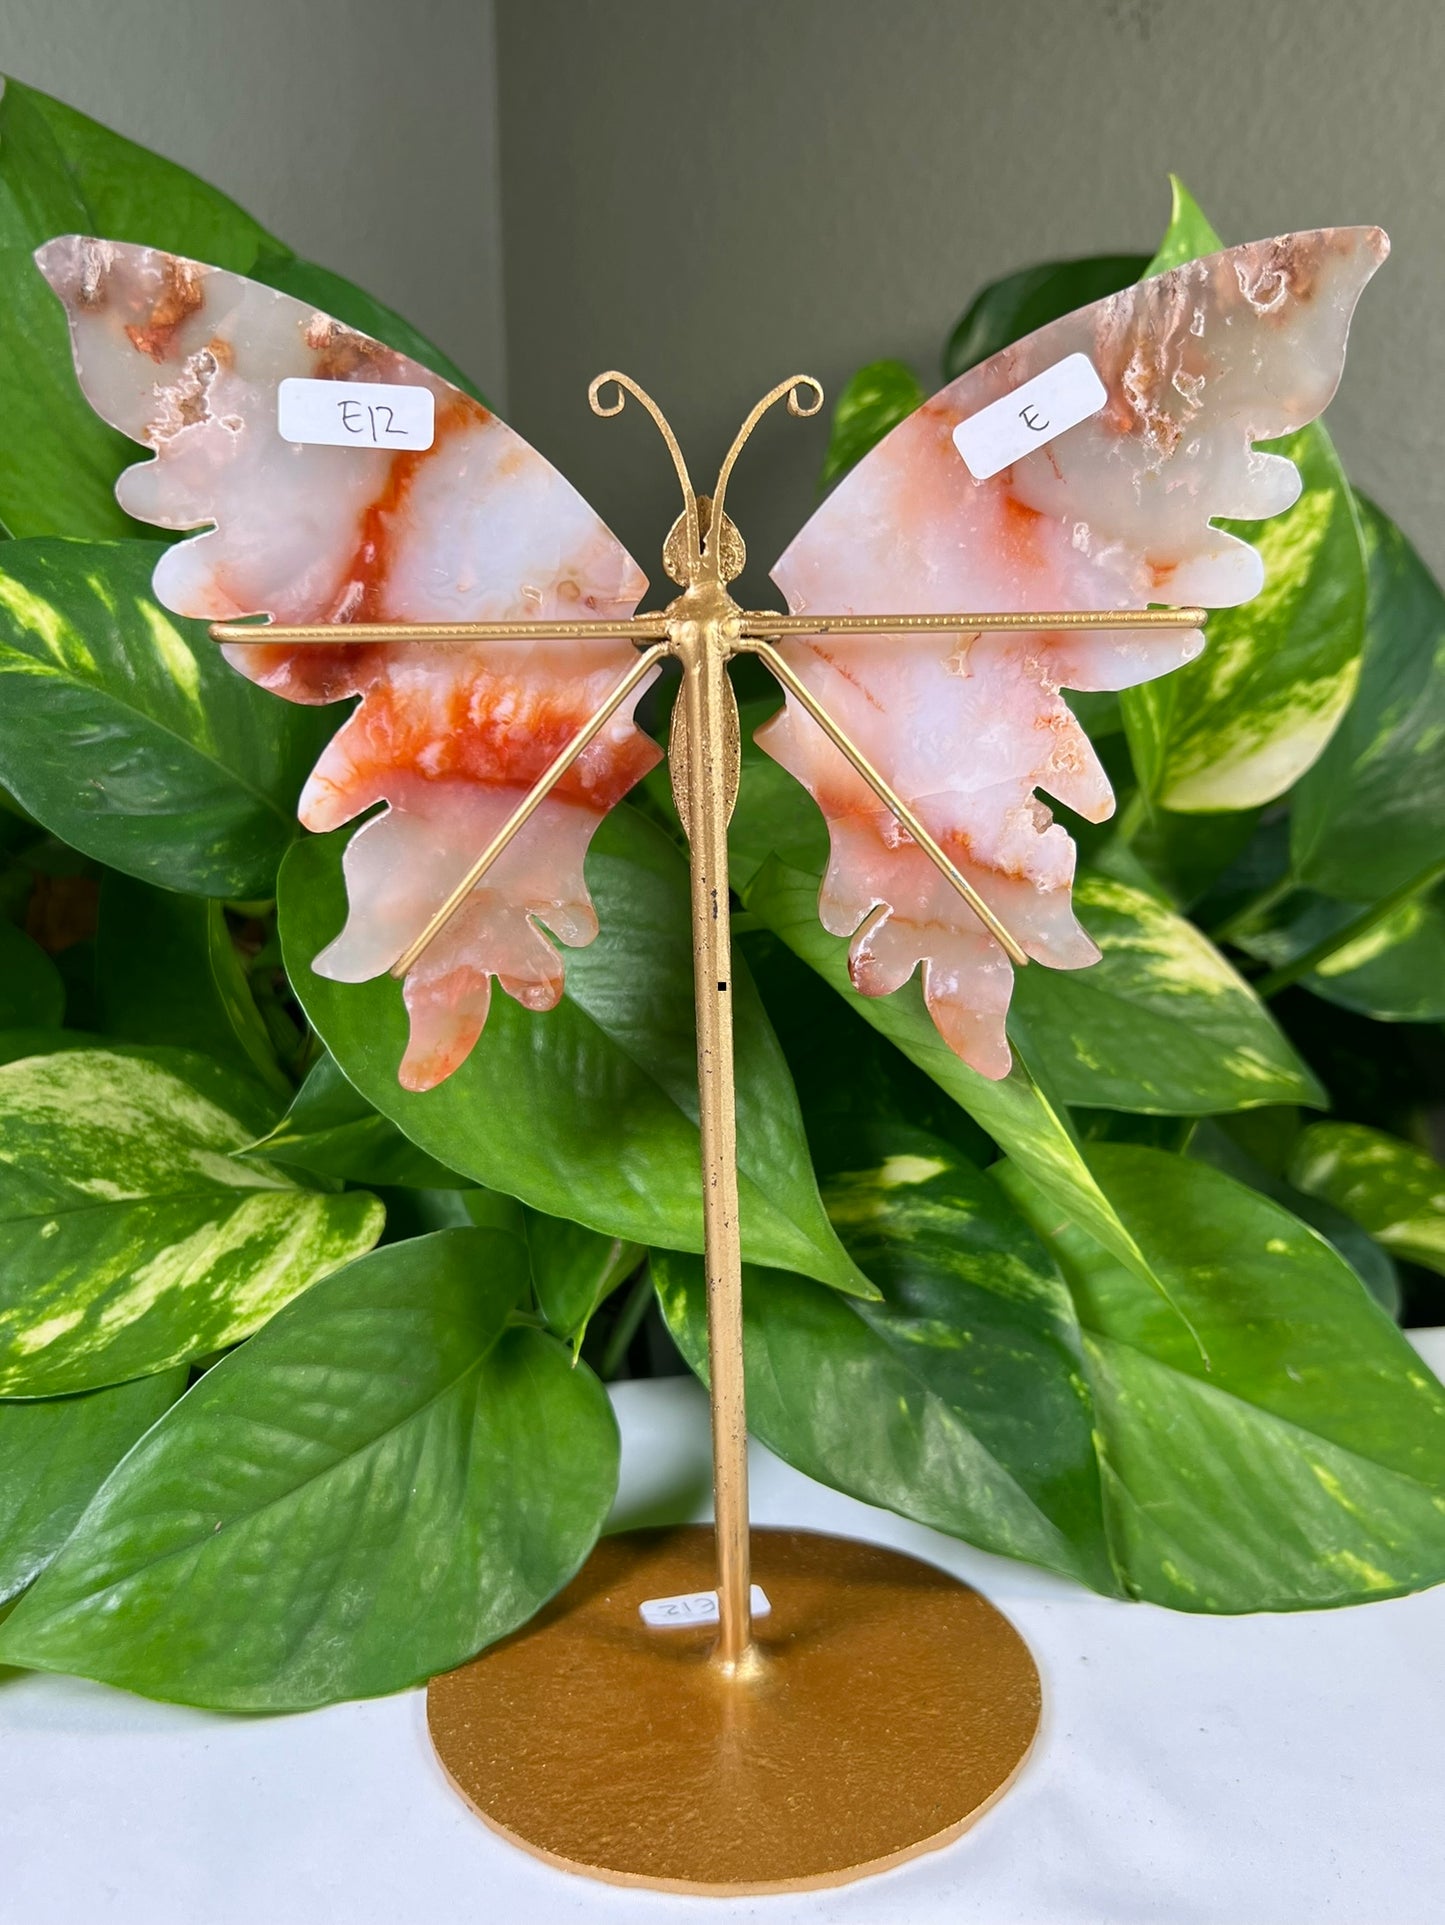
{"left": 498, "top": 0, "right": 1445, "bottom": 593}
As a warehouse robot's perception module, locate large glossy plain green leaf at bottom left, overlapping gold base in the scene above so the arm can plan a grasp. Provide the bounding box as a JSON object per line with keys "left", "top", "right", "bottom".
{"left": 0, "top": 1230, "right": 618, "bottom": 1711}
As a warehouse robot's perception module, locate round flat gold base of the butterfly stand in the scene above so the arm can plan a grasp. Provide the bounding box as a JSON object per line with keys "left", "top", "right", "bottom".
{"left": 427, "top": 1525, "right": 1039, "bottom": 1896}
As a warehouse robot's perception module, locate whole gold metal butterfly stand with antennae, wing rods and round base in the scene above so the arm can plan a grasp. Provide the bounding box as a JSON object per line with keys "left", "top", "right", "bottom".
{"left": 212, "top": 372, "right": 1204, "bottom": 1892}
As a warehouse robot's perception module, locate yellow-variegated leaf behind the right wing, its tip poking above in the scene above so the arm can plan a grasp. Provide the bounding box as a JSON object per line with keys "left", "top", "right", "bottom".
{"left": 1120, "top": 175, "right": 1366, "bottom": 812}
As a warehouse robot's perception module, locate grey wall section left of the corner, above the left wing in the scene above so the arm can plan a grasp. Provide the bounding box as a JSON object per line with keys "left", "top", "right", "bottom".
{"left": 0, "top": 0, "right": 504, "bottom": 397}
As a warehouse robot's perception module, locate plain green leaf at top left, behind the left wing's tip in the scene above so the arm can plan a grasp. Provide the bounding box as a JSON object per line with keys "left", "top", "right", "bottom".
{"left": 0, "top": 81, "right": 281, "bottom": 541}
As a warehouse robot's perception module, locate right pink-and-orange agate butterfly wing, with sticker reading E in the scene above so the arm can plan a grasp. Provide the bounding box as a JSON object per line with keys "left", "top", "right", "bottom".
{"left": 758, "top": 227, "right": 1387, "bottom": 1076}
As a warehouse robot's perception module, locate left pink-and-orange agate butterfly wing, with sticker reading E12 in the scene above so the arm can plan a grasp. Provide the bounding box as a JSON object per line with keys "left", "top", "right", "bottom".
{"left": 37, "top": 237, "right": 660, "bottom": 1090}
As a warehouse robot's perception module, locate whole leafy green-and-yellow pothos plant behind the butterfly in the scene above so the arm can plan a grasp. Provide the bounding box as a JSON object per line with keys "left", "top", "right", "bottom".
{"left": 0, "top": 83, "right": 1445, "bottom": 1709}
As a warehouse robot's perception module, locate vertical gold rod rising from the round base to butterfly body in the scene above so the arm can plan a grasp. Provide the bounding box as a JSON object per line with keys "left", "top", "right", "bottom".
{"left": 673, "top": 616, "right": 752, "bottom": 1675}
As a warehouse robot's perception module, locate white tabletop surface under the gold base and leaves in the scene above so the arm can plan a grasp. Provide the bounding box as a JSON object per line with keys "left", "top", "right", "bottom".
{"left": 0, "top": 1332, "right": 1445, "bottom": 1925}
